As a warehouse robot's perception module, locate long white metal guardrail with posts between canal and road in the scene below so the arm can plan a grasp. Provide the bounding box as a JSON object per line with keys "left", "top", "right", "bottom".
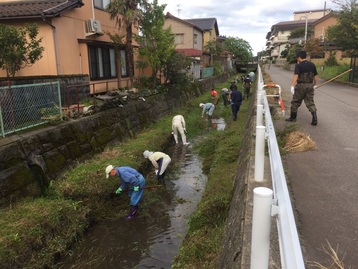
{"left": 251, "top": 66, "right": 305, "bottom": 269}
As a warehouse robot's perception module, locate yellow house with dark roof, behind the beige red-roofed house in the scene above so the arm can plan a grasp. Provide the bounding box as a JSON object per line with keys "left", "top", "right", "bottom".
{"left": 185, "top": 18, "right": 220, "bottom": 66}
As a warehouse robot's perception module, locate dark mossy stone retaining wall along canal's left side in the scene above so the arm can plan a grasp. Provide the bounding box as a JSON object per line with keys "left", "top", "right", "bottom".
{"left": 0, "top": 74, "right": 229, "bottom": 206}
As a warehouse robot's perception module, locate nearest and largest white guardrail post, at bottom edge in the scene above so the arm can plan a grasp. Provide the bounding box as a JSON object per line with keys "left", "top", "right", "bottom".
{"left": 250, "top": 187, "right": 273, "bottom": 269}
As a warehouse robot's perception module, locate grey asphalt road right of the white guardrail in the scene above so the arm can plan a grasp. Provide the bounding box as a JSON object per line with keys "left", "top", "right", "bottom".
{"left": 265, "top": 65, "right": 358, "bottom": 269}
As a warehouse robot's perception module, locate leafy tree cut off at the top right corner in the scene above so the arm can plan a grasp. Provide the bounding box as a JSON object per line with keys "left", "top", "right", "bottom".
{"left": 326, "top": 0, "right": 358, "bottom": 55}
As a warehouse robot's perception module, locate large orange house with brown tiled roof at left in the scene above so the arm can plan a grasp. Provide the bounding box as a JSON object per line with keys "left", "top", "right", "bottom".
{"left": 0, "top": 0, "right": 138, "bottom": 93}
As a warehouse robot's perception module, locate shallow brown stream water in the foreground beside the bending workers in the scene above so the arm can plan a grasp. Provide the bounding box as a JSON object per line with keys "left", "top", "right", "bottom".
{"left": 57, "top": 145, "right": 207, "bottom": 269}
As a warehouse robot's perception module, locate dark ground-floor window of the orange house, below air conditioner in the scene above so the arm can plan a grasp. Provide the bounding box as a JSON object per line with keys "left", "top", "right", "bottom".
{"left": 88, "top": 46, "right": 119, "bottom": 79}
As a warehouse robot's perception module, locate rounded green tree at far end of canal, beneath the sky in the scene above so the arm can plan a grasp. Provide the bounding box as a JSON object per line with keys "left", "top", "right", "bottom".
{"left": 224, "top": 37, "right": 252, "bottom": 67}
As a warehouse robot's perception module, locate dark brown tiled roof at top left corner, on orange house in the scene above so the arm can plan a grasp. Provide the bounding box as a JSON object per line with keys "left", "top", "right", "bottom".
{"left": 0, "top": 0, "right": 84, "bottom": 21}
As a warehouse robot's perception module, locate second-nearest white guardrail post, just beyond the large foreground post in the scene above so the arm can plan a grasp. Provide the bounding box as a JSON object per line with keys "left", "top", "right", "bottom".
{"left": 255, "top": 126, "right": 266, "bottom": 181}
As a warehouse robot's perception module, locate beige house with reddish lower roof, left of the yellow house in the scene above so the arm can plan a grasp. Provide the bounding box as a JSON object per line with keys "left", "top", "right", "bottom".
{"left": 164, "top": 12, "right": 204, "bottom": 80}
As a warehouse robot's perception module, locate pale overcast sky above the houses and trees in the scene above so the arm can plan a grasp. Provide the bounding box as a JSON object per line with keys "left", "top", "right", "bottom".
{"left": 158, "top": 0, "right": 337, "bottom": 55}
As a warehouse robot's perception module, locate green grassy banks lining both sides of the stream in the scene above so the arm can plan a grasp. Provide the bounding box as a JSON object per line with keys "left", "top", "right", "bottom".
{"left": 0, "top": 74, "right": 255, "bottom": 269}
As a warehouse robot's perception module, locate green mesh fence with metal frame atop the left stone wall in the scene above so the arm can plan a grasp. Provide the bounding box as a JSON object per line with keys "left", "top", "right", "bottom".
{"left": 0, "top": 82, "right": 62, "bottom": 137}
